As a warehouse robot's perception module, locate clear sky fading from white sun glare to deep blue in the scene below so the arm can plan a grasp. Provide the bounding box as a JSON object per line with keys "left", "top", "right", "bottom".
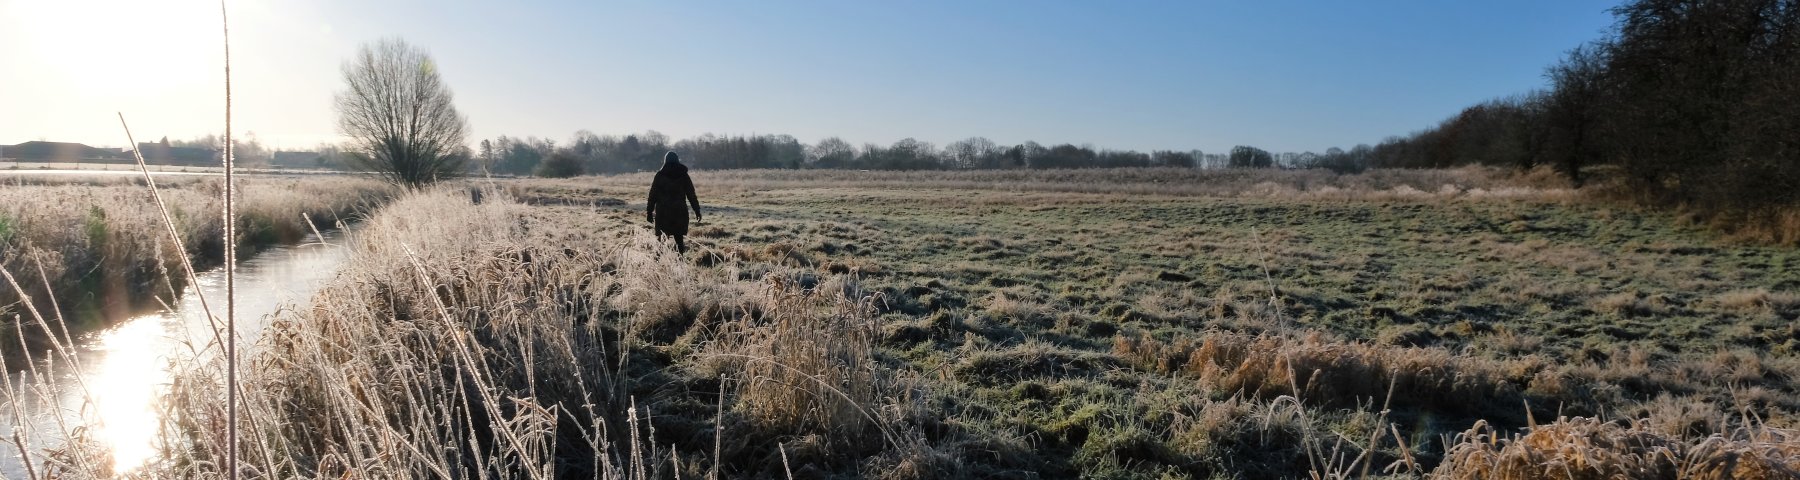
{"left": 0, "top": 0, "right": 1616, "bottom": 153}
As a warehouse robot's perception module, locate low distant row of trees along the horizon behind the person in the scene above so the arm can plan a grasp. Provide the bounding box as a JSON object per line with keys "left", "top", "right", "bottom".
{"left": 473, "top": 124, "right": 1548, "bottom": 176}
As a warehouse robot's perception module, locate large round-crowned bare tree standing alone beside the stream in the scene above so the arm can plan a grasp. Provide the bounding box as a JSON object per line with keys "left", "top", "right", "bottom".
{"left": 337, "top": 38, "right": 468, "bottom": 187}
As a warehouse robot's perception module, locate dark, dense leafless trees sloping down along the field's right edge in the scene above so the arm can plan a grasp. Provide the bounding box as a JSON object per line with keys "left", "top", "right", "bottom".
{"left": 1318, "top": 0, "right": 1800, "bottom": 243}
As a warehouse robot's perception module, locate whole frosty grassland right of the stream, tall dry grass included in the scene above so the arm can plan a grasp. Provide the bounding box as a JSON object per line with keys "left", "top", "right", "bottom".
{"left": 17, "top": 171, "right": 1800, "bottom": 478}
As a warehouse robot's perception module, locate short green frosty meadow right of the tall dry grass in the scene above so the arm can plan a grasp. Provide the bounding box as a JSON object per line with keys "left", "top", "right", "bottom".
{"left": 583, "top": 172, "right": 1800, "bottom": 475}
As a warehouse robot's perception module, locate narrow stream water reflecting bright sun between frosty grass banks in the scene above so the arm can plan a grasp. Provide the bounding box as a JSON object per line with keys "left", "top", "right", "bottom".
{"left": 0, "top": 230, "right": 349, "bottom": 478}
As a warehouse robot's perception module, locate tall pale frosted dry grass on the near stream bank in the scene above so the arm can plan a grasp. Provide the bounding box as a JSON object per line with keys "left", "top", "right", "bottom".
{"left": 125, "top": 191, "right": 936, "bottom": 478}
